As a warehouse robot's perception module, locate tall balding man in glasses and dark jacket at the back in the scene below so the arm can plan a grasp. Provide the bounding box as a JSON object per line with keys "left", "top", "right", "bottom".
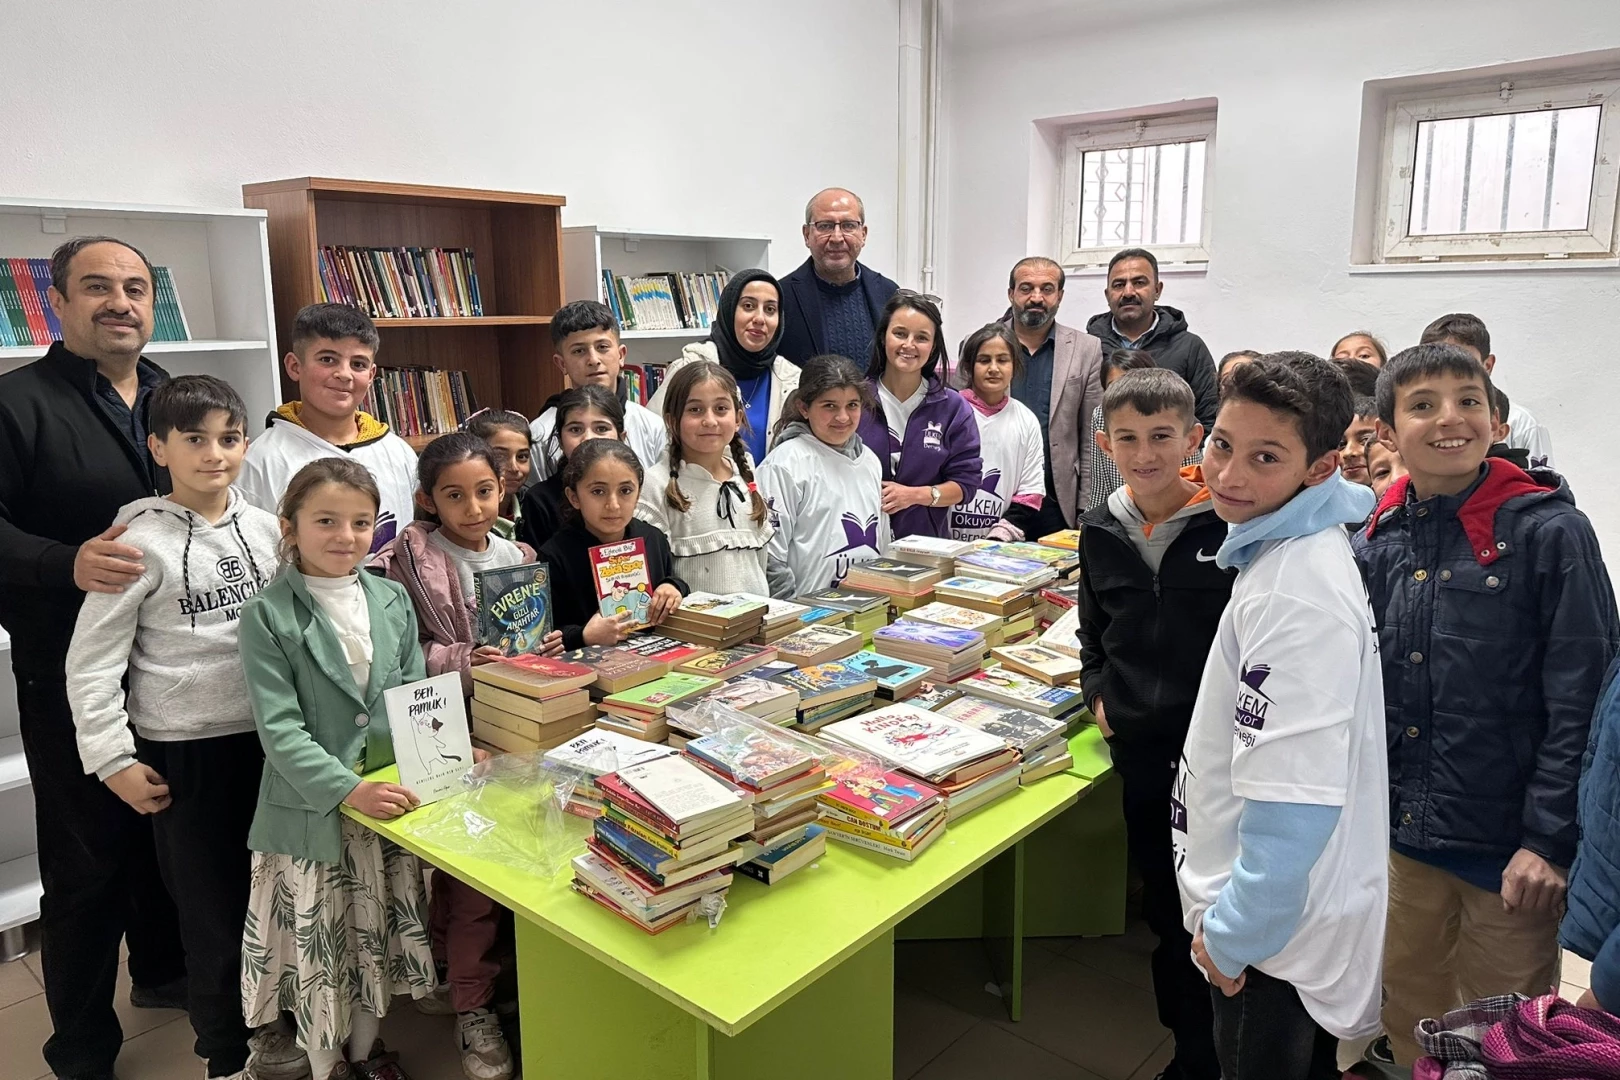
{"left": 778, "top": 188, "right": 899, "bottom": 369}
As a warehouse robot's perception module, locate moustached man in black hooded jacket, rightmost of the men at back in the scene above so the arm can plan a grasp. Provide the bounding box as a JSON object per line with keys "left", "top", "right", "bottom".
{"left": 1085, "top": 248, "right": 1220, "bottom": 431}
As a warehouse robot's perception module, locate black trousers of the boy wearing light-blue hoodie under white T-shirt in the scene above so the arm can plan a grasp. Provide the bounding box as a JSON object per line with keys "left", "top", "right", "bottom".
{"left": 1209, "top": 968, "right": 1340, "bottom": 1080}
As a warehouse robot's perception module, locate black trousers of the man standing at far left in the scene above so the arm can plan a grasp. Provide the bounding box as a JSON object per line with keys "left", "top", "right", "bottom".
{"left": 16, "top": 670, "right": 186, "bottom": 1080}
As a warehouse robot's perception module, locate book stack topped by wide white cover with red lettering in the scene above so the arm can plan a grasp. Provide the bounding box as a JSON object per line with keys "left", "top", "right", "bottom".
{"left": 821, "top": 703, "right": 1022, "bottom": 821}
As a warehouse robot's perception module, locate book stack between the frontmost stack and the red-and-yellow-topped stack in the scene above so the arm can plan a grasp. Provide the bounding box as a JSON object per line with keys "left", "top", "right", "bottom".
{"left": 685, "top": 725, "right": 833, "bottom": 884}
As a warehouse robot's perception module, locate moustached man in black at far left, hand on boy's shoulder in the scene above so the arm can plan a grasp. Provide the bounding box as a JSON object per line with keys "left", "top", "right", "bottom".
{"left": 0, "top": 236, "right": 185, "bottom": 1080}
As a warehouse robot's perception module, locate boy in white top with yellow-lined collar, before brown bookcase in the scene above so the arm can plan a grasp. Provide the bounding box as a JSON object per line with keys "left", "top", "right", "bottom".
{"left": 238, "top": 304, "right": 416, "bottom": 552}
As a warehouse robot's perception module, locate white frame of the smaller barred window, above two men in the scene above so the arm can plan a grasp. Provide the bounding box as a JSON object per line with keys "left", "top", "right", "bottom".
{"left": 1056, "top": 108, "right": 1215, "bottom": 270}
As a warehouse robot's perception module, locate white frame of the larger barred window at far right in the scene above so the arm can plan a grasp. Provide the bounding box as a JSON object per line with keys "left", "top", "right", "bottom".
{"left": 1377, "top": 73, "right": 1620, "bottom": 264}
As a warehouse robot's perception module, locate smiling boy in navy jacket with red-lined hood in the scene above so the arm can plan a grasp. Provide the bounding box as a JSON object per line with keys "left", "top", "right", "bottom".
{"left": 1354, "top": 345, "right": 1620, "bottom": 1065}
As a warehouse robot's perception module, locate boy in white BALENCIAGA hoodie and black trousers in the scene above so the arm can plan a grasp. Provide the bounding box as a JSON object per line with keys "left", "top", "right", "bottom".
{"left": 66, "top": 376, "right": 280, "bottom": 1077}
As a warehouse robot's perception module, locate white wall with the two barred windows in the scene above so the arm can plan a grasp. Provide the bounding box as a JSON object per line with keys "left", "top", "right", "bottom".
{"left": 941, "top": 0, "right": 1620, "bottom": 544}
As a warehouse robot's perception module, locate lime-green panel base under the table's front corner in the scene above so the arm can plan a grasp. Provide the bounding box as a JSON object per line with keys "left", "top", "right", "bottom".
{"left": 517, "top": 916, "right": 894, "bottom": 1080}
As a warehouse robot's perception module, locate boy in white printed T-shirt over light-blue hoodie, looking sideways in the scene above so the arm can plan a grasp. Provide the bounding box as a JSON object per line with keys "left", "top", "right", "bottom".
{"left": 1171, "top": 353, "right": 1388, "bottom": 1080}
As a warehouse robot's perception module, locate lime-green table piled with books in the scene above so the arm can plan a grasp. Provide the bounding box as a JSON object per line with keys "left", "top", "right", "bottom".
{"left": 343, "top": 769, "right": 1090, "bottom": 1080}
